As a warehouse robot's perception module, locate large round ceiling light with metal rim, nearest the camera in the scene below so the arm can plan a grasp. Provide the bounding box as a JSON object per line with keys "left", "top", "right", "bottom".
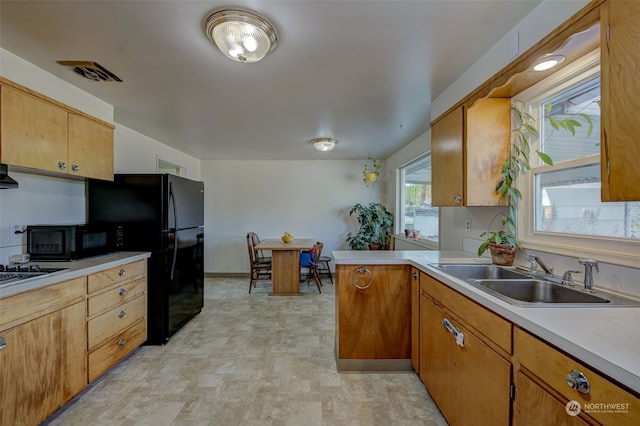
{"left": 204, "top": 9, "right": 278, "bottom": 63}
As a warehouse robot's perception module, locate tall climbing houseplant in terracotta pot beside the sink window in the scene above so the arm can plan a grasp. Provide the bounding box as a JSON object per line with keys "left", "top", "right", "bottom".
{"left": 478, "top": 102, "right": 593, "bottom": 265}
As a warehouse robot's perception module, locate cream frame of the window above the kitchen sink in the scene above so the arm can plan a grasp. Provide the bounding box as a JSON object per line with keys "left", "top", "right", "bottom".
{"left": 512, "top": 50, "right": 640, "bottom": 267}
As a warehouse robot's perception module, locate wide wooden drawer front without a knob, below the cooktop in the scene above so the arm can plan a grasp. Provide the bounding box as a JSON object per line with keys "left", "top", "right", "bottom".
{"left": 0, "top": 277, "right": 85, "bottom": 331}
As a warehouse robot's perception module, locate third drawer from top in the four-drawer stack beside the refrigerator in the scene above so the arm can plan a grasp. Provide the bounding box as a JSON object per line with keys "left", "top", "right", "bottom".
{"left": 88, "top": 296, "right": 147, "bottom": 350}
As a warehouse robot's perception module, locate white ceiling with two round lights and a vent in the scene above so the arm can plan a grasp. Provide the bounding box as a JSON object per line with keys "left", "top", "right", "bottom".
{"left": 0, "top": 0, "right": 540, "bottom": 160}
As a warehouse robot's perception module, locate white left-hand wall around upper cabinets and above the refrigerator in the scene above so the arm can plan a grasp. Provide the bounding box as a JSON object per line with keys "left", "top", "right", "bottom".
{"left": 0, "top": 49, "right": 200, "bottom": 264}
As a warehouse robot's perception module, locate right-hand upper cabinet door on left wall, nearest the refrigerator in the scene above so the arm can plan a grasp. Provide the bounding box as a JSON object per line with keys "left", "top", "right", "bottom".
{"left": 69, "top": 114, "right": 113, "bottom": 180}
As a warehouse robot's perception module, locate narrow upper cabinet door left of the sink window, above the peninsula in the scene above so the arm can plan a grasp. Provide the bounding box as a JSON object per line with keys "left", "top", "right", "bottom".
{"left": 431, "top": 106, "right": 465, "bottom": 207}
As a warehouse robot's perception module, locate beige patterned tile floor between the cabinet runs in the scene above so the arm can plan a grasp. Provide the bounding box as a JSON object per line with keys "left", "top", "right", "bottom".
{"left": 46, "top": 278, "right": 446, "bottom": 426}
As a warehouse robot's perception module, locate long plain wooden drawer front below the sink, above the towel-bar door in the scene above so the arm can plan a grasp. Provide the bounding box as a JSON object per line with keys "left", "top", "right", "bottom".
{"left": 420, "top": 275, "right": 512, "bottom": 354}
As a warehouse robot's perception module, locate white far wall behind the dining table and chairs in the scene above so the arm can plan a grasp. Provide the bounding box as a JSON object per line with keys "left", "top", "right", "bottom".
{"left": 202, "top": 159, "right": 385, "bottom": 273}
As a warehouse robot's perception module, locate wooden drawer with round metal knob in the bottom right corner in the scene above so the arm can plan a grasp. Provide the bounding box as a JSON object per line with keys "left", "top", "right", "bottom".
{"left": 514, "top": 328, "right": 640, "bottom": 425}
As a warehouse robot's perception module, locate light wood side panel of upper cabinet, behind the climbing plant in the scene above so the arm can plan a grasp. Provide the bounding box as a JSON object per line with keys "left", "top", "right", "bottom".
{"left": 465, "top": 98, "right": 511, "bottom": 206}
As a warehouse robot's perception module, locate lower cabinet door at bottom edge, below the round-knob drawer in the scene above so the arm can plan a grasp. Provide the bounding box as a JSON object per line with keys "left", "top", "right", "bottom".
{"left": 513, "top": 371, "right": 588, "bottom": 426}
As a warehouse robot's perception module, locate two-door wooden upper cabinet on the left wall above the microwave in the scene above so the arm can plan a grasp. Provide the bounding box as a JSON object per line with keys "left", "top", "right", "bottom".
{"left": 0, "top": 78, "right": 114, "bottom": 180}
